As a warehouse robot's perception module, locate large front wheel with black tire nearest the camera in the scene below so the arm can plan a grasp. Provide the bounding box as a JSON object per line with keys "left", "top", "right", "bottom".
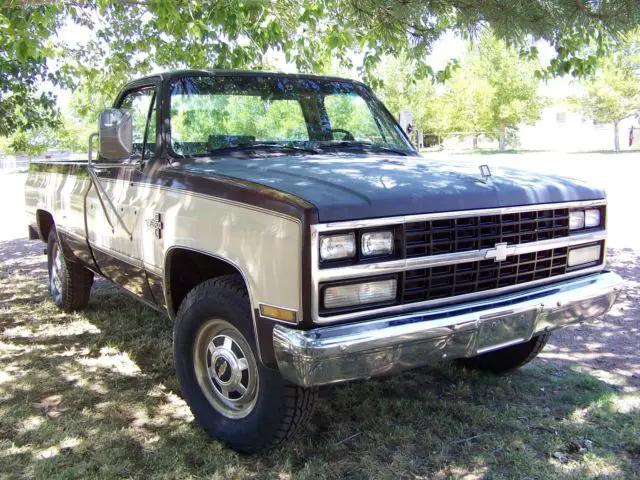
{"left": 173, "top": 275, "right": 316, "bottom": 453}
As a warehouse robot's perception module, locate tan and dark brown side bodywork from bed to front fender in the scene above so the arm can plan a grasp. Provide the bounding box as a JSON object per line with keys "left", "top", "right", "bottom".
{"left": 25, "top": 158, "right": 314, "bottom": 363}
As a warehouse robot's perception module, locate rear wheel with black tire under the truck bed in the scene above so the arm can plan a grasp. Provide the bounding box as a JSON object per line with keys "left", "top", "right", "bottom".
{"left": 47, "top": 227, "right": 93, "bottom": 312}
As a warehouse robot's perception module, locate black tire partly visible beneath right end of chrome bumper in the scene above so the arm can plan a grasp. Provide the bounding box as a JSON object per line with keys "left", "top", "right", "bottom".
{"left": 458, "top": 332, "right": 551, "bottom": 374}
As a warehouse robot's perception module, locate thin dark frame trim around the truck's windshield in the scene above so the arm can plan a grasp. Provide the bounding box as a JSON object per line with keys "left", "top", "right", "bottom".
{"left": 162, "top": 70, "right": 420, "bottom": 160}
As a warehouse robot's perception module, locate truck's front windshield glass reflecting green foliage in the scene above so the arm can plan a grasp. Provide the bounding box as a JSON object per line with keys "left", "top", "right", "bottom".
{"left": 170, "top": 75, "right": 415, "bottom": 156}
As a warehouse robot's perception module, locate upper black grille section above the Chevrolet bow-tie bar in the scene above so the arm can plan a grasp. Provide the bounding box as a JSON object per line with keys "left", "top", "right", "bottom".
{"left": 405, "top": 208, "right": 569, "bottom": 258}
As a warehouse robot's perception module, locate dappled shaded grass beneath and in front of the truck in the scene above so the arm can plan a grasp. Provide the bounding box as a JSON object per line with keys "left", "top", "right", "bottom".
{"left": 0, "top": 264, "right": 640, "bottom": 479}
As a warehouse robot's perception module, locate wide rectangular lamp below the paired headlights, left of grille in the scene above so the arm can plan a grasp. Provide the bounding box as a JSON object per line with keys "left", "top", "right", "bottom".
{"left": 324, "top": 278, "right": 398, "bottom": 308}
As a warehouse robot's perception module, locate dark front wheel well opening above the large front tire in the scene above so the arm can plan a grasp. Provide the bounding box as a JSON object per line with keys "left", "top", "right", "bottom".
{"left": 165, "top": 248, "right": 246, "bottom": 317}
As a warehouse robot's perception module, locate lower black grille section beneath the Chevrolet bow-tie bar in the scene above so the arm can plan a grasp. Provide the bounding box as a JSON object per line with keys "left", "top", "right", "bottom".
{"left": 400, "top": 247, "right": 567, "bottom": 303}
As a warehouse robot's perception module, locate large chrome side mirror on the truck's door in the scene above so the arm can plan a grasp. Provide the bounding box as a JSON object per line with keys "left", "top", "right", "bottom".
{"left": 98, "top": 108, "right": 133, "bottom": 162}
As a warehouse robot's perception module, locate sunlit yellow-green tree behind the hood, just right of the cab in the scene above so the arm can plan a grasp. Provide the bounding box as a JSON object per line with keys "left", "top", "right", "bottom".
{"left": 377, "top": 32, "right": 544, "bottom": 150}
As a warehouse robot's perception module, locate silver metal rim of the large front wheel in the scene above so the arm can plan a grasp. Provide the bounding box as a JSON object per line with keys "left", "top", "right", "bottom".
{"left": 193, "top": 318, "right": 258, "bottom": 418}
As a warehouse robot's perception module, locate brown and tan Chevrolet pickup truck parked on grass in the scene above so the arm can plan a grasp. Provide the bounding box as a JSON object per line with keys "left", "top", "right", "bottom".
{"left": 25, "top": 70, "right": 621, "bottom": 452}
